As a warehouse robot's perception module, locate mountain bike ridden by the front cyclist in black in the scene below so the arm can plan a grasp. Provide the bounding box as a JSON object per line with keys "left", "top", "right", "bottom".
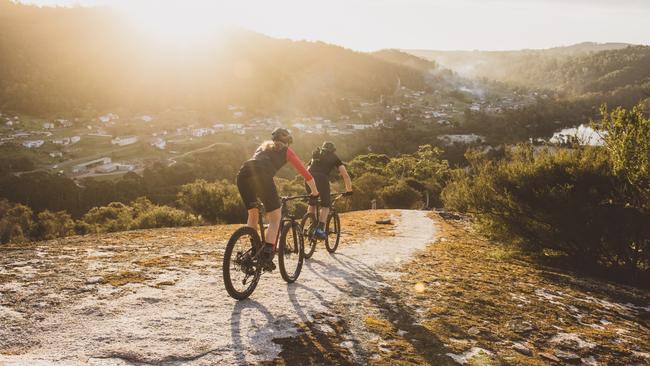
{"left": 300, "top": 192, "right": 351, "bottom": 259}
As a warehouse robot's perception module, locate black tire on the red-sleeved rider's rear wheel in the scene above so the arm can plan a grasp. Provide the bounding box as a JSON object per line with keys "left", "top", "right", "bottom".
{"left": 223, "top": 226, "right": 262, "bottom": 300}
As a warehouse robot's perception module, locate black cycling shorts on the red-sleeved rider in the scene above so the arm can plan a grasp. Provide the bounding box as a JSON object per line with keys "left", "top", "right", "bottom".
{"left": 237, "top": 162, "right": 281, "bottom": 212}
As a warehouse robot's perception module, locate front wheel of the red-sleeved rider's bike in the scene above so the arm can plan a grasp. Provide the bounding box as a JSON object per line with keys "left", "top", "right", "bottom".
{"left": 278, "top": 221, "right": 304, "bottom": 283}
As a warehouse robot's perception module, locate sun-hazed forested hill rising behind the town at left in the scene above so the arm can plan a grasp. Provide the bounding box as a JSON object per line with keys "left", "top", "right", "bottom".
{"left": 0, "top": 0, "right": 427, "bottom": 114}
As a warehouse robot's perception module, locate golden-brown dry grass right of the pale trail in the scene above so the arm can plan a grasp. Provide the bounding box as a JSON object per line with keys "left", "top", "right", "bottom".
{"left": 364, "top": 215, "right": 650, "bottom": 365}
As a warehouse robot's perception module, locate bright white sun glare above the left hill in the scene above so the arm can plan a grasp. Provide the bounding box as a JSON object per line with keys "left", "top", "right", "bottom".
{"left": 118, "top": 0, "right": 227, "bottom": 43}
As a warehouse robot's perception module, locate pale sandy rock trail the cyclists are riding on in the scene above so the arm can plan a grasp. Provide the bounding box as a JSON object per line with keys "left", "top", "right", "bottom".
{"left": 0, "top": 211, "right": 435, "bottom": 365}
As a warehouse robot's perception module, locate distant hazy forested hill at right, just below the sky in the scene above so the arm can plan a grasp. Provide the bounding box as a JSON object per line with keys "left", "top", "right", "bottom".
{"left": 408, "top": 43, "right": 650, "bottom": 106}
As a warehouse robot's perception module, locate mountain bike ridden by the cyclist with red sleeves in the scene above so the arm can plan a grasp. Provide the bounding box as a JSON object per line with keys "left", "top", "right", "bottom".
{"left": 223, "top": 195, "right": 310, "bottom": 300}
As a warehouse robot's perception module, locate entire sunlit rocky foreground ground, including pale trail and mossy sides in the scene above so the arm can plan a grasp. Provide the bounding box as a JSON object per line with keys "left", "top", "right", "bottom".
{"left": 0, "top": 210, "right": 650, "bottom": 365}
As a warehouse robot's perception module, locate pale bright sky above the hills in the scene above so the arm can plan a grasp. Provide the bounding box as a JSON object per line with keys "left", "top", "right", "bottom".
{"left": 21, "top": 0, "right": 650, "bottom": 51}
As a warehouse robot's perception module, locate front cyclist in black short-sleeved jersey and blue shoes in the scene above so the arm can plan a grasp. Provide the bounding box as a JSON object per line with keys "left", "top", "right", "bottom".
{"left": 306, "top": 141, "right": 352, "bottom": 239}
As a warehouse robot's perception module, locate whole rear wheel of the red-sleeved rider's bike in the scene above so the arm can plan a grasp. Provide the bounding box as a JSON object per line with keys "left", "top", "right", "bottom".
{"left": 223, "top": 226, "right": 262, "bottom": 300}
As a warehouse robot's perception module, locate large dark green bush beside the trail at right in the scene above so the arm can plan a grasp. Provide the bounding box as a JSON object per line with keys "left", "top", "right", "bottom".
{"left": 442, "top": 145, "right": 650, "bottom": 269}
